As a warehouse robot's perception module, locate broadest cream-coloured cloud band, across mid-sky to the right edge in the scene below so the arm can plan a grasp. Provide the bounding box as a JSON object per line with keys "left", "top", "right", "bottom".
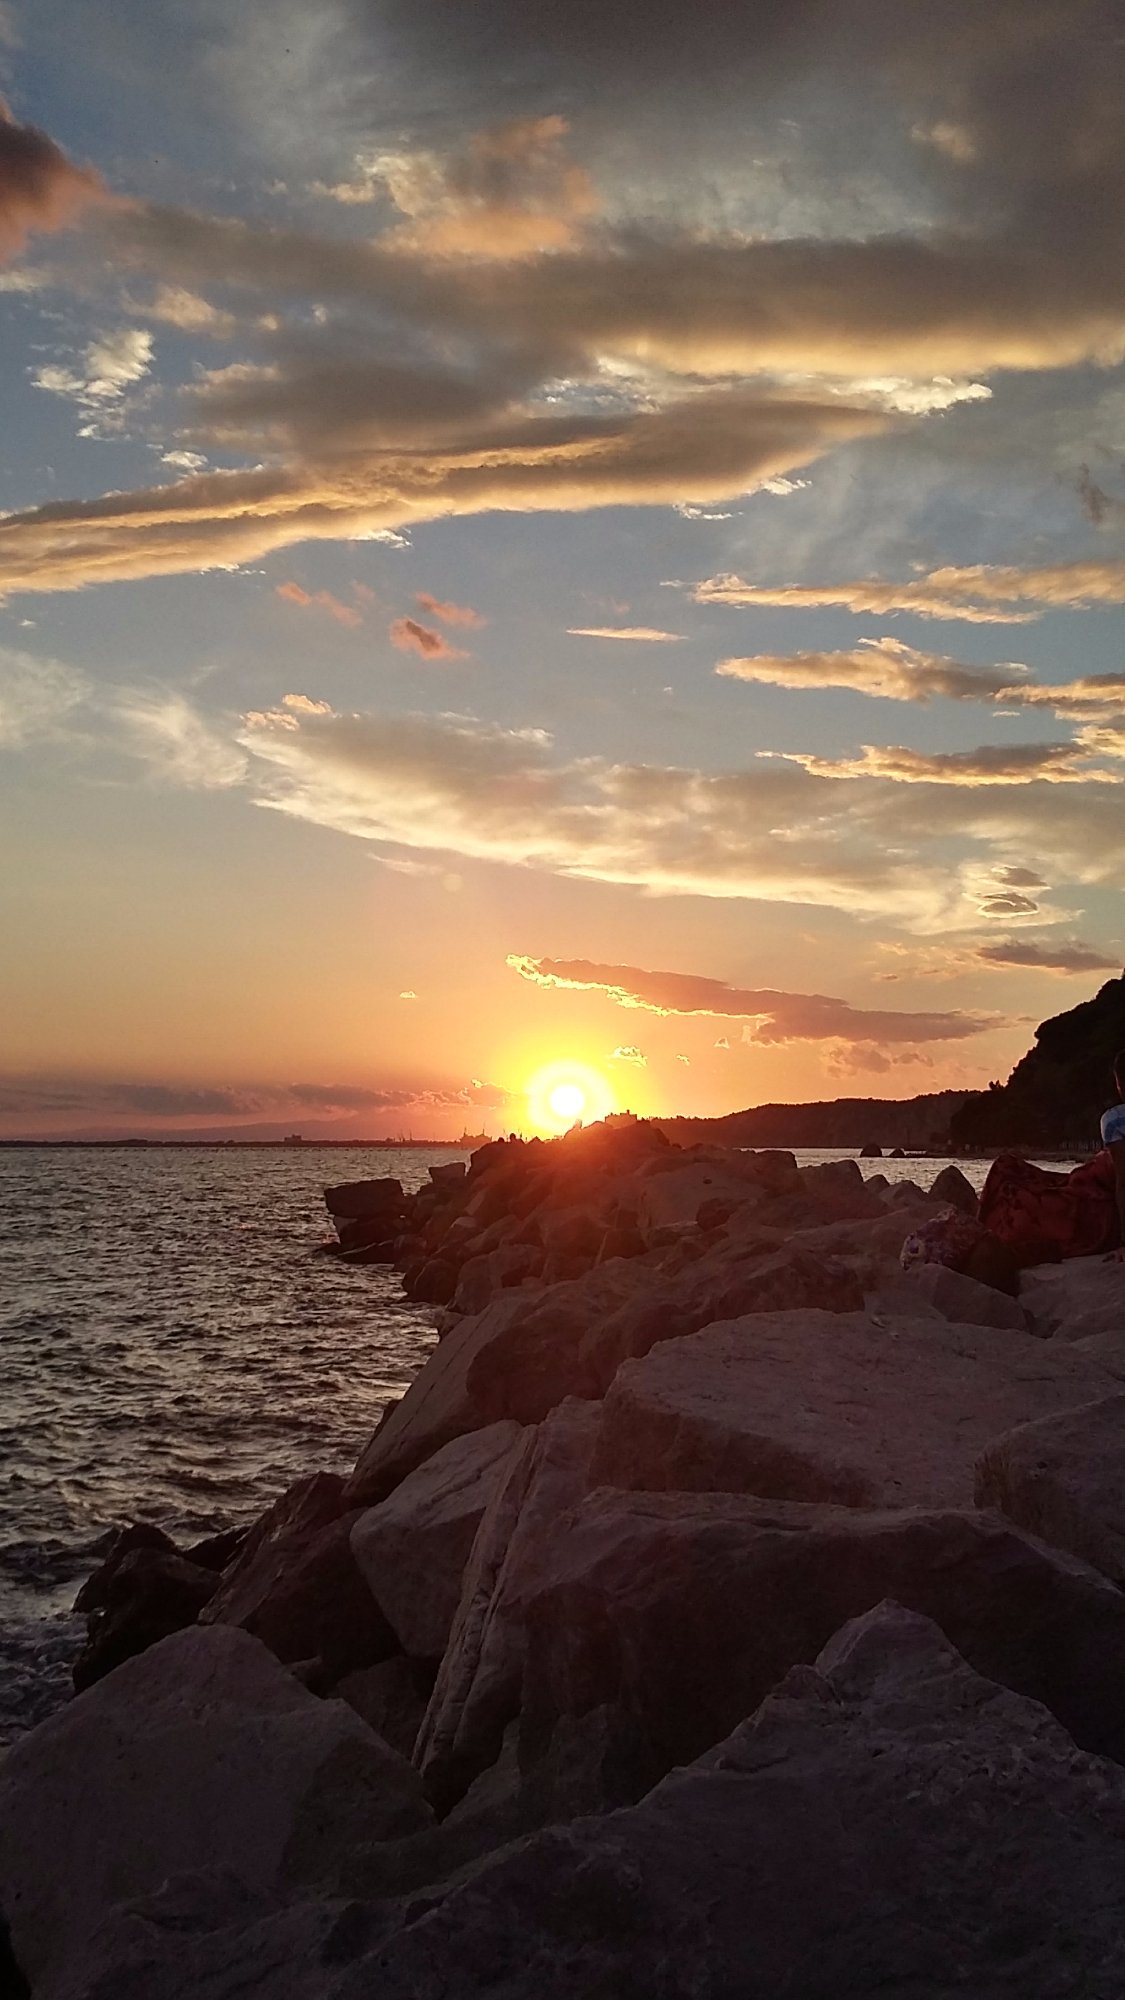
{"left": 230, "top": 710, "right": 1125, "bottom": 930}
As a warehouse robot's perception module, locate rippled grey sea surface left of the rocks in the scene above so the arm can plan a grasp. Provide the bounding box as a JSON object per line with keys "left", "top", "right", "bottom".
{"left": 0, "top": 1146, "right": 456, "bottom": 1740}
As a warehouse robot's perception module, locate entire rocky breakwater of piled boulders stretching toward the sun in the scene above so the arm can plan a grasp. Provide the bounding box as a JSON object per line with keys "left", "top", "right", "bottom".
{"left": 0, "top": 1126, "right": 1125, "bottom": 2000}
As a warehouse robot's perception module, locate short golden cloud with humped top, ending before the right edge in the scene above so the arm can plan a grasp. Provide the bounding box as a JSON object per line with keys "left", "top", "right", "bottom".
{"left": 715, "top": 638, "right": 1020, "bottom": 704}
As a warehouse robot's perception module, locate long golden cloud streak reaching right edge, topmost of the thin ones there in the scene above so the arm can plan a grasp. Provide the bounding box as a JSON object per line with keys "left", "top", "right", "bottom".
{"left": 693, "top": 556, "right": 1125, "bottom": 624}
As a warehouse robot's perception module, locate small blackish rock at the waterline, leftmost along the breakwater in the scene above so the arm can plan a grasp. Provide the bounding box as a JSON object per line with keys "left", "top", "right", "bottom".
{"left": 74, "top": 1546, "right": 218, "bottom": 1694}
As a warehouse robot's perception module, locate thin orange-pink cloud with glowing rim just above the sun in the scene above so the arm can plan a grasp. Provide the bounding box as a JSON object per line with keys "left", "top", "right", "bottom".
{"left": 508, "top": 952, "right": 1001, "bottom": 1046}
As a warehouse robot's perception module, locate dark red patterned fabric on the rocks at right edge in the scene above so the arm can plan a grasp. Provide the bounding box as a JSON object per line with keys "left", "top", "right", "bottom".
{"left": 979, "top": 1148, "right": 1121, "bottom": 1264}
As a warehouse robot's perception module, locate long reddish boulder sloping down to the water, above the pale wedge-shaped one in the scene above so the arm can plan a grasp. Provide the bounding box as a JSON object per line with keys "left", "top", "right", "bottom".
{"left": 344, "top": 1258, "right": 651, "bottom": 1506}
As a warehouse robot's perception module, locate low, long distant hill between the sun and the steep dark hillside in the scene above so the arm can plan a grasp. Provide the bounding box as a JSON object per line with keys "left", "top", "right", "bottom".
{"left": 657, "top": 1090, "right": 973, "bottom": 1152}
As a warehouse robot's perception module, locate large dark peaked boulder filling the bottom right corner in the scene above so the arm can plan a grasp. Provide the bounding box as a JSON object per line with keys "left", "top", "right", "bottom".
{"left": 332, "top": 1606, "right": 1125, "bottom": 2000}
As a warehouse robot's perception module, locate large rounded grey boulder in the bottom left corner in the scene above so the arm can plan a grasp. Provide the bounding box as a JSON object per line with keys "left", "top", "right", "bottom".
{"left": 0, "top": 1626, "right": 430, "bottom": 2000}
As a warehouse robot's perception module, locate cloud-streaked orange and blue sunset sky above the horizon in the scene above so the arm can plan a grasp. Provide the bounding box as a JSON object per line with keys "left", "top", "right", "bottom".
{"left": 0, "top": 0, "right": 1125, "bottom": 1138}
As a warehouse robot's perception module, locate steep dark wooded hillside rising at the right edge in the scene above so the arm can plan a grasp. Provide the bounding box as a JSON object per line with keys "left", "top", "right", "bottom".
{"left": 951, "top": 974, "right": 1125, "bottom": 1150}
